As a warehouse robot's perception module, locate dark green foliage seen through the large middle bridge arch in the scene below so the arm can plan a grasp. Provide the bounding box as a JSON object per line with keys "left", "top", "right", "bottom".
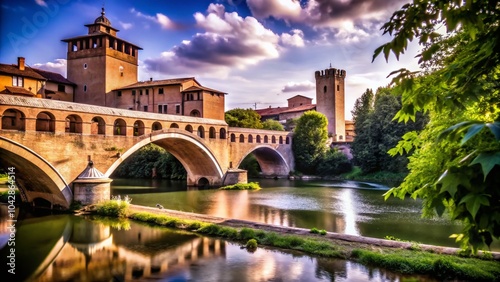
{"left": 113, "top": 144, "right": 187, "bottom": 179}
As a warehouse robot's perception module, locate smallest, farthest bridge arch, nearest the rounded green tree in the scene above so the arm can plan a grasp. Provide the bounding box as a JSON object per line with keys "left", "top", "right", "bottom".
{"left": 237, "top": 144, "right": 290, "bottom": 176}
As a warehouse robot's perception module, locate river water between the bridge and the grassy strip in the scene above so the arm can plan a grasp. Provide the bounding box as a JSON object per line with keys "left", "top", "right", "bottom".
{"left": 112, "top": 179, "right": 494, "bottom": 251}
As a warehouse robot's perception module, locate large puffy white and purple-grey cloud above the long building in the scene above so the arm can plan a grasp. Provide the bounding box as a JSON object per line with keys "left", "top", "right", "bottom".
{"left": 144, "top": 4, "right": 304, "bottom": 76}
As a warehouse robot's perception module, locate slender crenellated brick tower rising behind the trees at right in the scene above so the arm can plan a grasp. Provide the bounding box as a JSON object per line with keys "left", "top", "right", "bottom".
{"left": 314, "top": 67, "right": 346, "bottom": 142}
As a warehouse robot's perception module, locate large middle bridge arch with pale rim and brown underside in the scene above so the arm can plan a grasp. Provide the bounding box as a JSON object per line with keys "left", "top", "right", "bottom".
{"left": 105, "top": 128, "right": 224, "bottom": 186}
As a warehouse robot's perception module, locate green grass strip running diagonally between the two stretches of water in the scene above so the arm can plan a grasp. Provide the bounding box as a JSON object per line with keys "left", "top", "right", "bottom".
{"left": 92, "top": 199, "right": 500, "bottom": 281}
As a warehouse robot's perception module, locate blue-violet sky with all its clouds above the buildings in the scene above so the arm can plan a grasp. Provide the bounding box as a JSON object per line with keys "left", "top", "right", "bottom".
{"left": 0, "top": 0, "right": 418, "bottom": 119}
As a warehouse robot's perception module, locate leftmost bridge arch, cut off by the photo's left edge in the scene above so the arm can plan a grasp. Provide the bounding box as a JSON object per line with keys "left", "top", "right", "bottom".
{"left": 0, "top": 136, "right": 73, "bottom": 209}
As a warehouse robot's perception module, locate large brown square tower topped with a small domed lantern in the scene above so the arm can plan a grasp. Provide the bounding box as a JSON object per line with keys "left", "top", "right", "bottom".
{"left": 62, "top": 8, "right": 142, "bottom": 107}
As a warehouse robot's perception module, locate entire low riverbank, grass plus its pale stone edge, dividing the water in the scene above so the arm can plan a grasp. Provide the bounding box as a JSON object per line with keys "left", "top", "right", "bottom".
{"left": 80, "top": 204, "right": 500, "bottom": 281}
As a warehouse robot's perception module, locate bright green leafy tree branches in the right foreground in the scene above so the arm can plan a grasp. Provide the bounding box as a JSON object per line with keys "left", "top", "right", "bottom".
{"left": 374, "top": 0, "right": 500, "bottom": 252}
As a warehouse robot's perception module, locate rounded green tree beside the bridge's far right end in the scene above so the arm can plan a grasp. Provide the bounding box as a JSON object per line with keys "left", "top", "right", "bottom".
{"left": 292, "top": 111, "right": 328, "bottom": 174}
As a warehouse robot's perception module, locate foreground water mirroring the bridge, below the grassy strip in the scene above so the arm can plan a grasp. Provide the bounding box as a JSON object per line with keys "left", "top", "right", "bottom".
{"left": 1, "top": 215, "right": 438, "bottom": 281}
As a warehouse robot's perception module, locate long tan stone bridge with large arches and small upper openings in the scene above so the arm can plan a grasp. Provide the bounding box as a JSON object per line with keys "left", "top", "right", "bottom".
{"left": 0, "top": 94, "right": 294, "bottom": 208}
